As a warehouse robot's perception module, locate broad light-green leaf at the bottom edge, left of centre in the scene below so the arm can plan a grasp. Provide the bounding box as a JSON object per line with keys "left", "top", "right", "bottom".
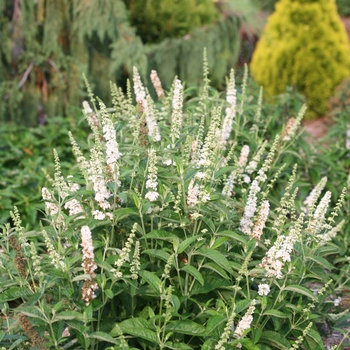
{"left": 119, "top": 318, "right": 158, "bottom": 344}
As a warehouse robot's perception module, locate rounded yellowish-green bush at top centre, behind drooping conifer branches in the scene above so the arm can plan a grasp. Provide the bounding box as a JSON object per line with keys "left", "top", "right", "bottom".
{"left": 124, "top": 0, "right": 219, "bottom": 43}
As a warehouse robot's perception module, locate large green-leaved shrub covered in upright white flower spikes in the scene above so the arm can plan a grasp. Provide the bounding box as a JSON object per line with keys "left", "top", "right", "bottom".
{"left": 0, "top": 61, "right": 344, "bottom": 350}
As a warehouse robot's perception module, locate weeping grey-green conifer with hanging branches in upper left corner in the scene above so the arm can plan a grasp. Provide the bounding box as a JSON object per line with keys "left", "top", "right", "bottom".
{"left": 0, "top": 0, "right": 147, "bottom": 125}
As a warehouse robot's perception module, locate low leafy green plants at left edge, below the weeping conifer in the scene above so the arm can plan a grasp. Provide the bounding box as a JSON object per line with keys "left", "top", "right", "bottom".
{"left": 0, "top": 112, "right": 86, "bottom": 227}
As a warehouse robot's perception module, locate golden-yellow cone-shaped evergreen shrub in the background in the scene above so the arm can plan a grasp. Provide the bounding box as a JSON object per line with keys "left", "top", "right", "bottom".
{"left": 251, "top": 0, "right": 350, "bottom": 118}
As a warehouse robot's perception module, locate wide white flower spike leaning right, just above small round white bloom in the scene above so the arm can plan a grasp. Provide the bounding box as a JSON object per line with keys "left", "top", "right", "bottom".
{"left": 261, "top": 213, "right": 304, "bottom": 279}
